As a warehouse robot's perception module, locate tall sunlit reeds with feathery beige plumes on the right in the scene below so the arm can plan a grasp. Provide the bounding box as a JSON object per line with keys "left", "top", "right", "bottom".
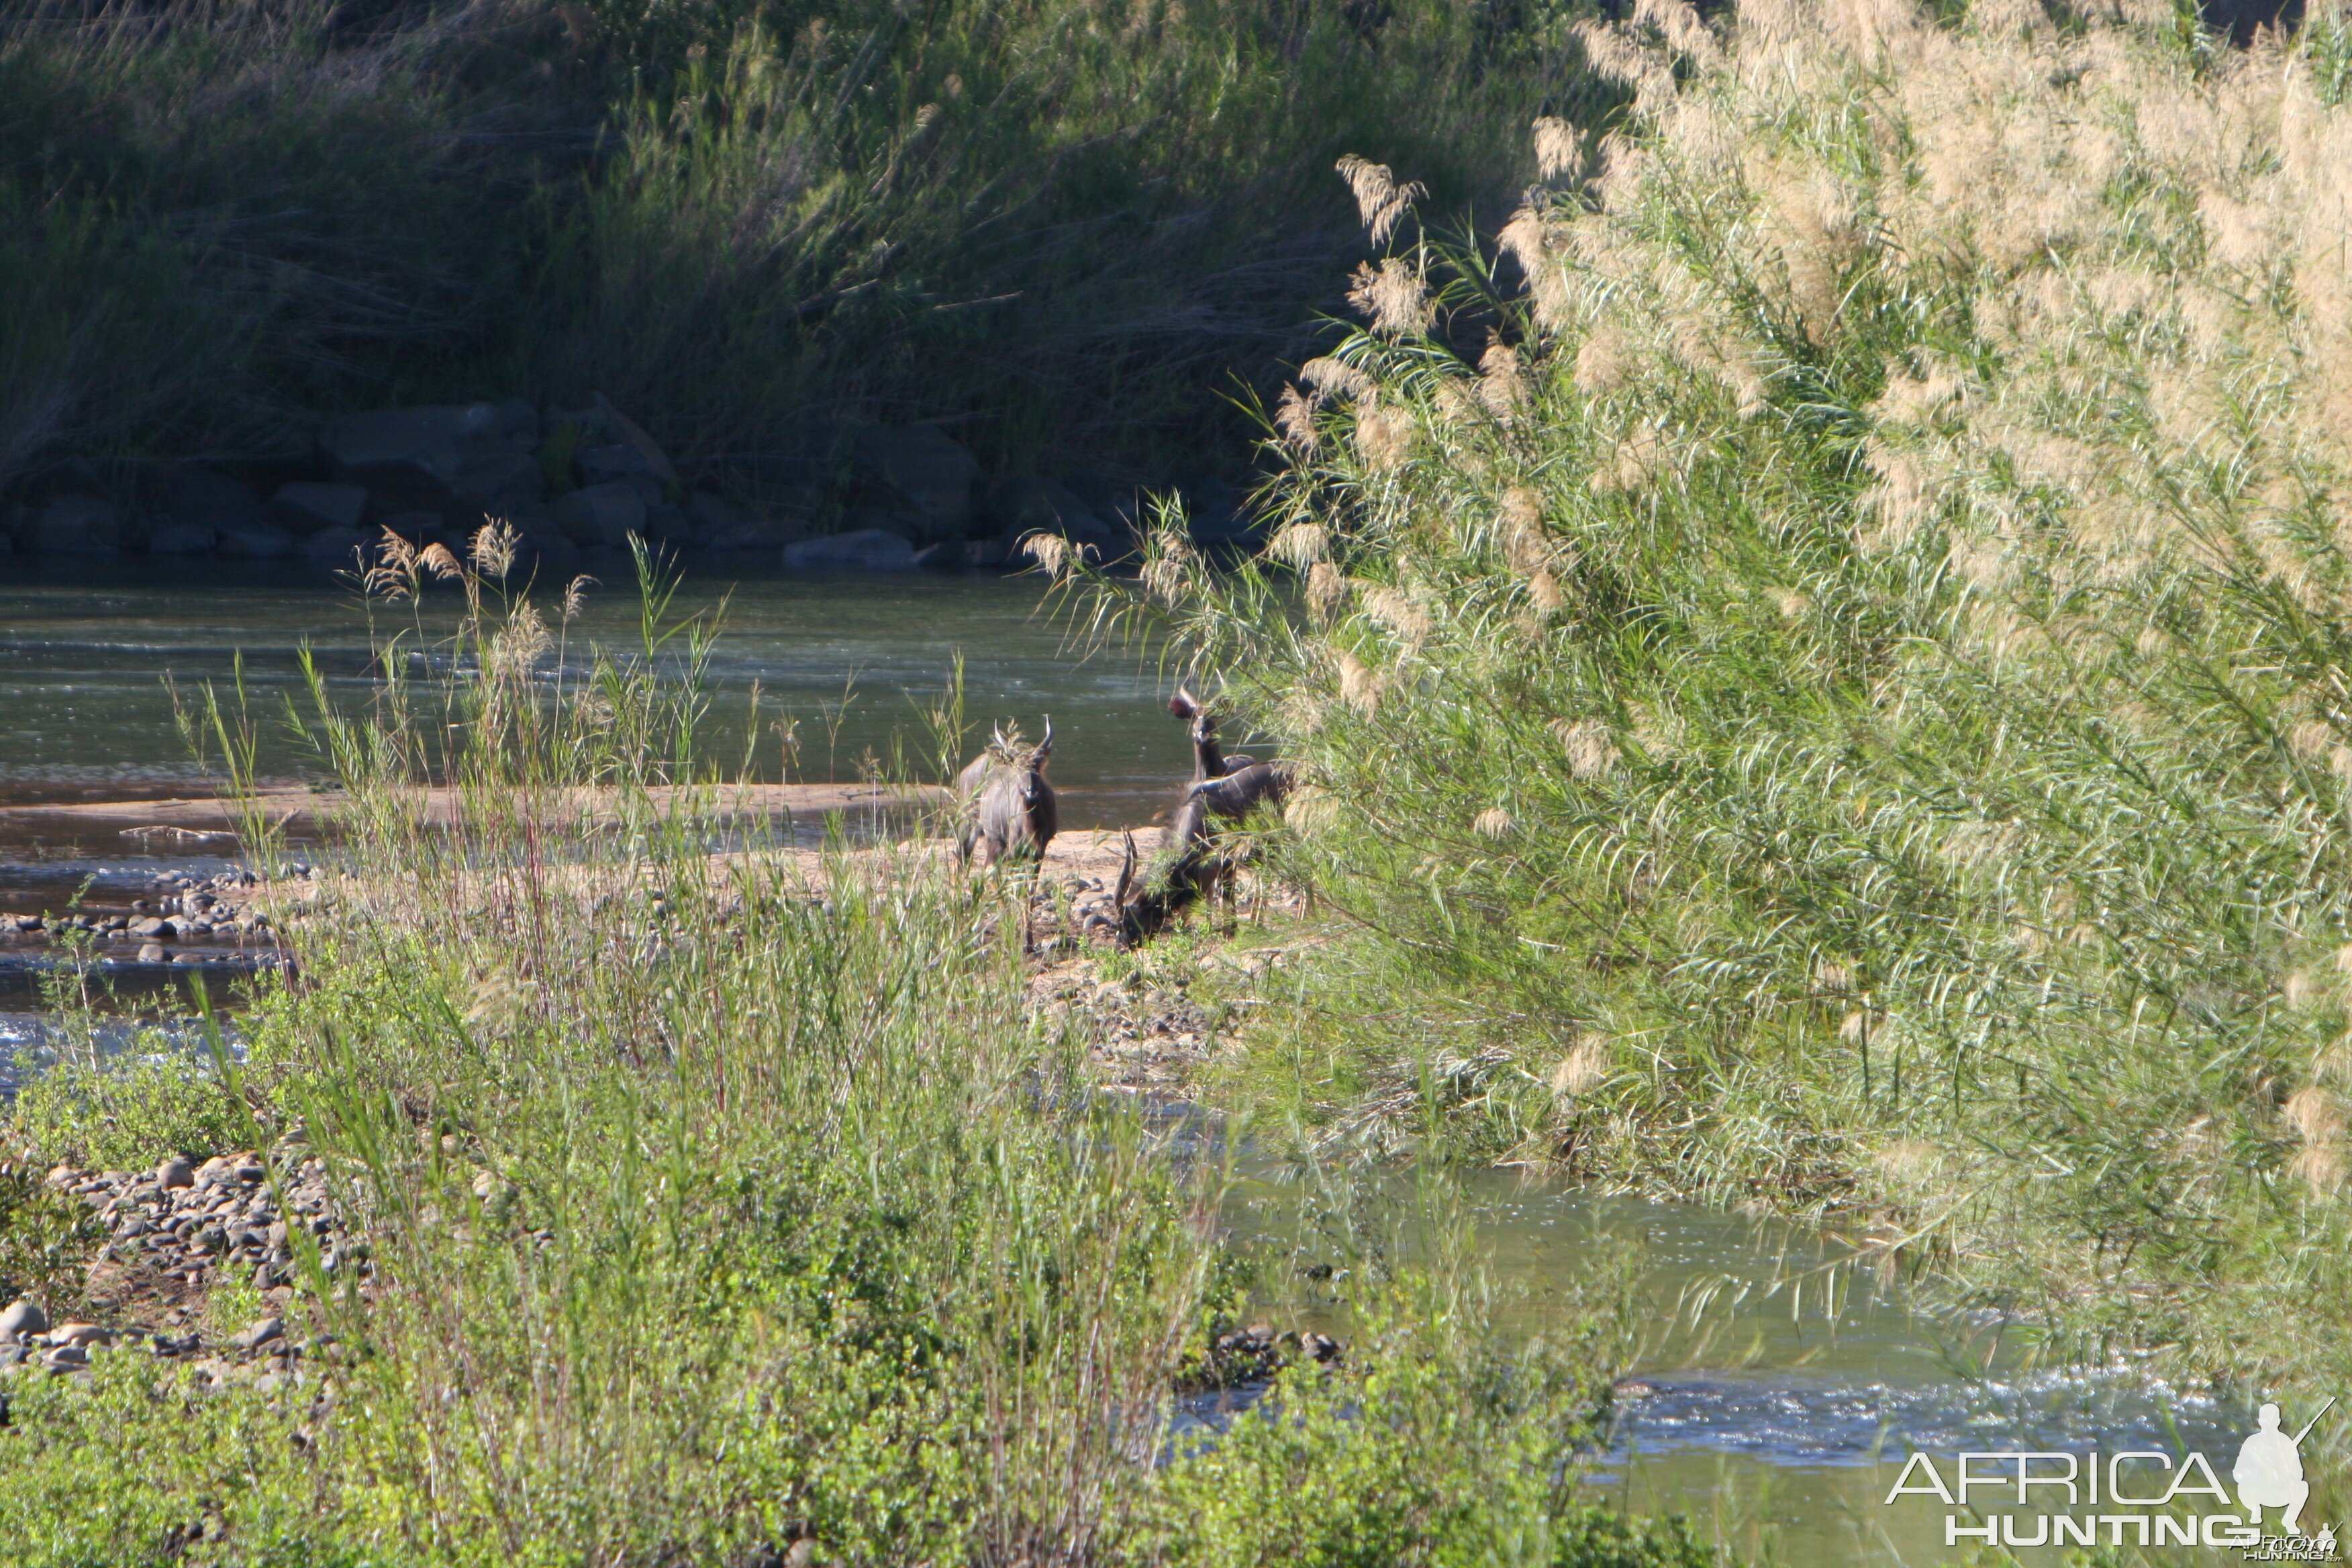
{"left": 1077, "top": 0, "right": 2352, "bottom": 1401}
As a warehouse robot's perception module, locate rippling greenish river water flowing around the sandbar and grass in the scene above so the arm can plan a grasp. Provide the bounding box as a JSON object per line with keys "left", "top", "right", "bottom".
{"left": 0, "top": 562, "right": 2276, "bottom": 1568}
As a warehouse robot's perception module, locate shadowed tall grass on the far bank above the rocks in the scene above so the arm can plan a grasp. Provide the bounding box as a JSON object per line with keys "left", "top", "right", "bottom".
{"left": 0, "top": 0, "right": 1590, "bottom": 477}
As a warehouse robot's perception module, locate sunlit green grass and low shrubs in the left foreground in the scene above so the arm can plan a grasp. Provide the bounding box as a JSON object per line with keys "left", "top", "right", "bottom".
{"left": 0, "top": 557, "right": 1712, "bottom": 1568}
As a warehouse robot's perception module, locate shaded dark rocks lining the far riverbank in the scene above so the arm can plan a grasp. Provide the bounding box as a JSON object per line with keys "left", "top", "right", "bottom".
{"left": 0, "top": 397, "right": 1249, "bottom": 571}
